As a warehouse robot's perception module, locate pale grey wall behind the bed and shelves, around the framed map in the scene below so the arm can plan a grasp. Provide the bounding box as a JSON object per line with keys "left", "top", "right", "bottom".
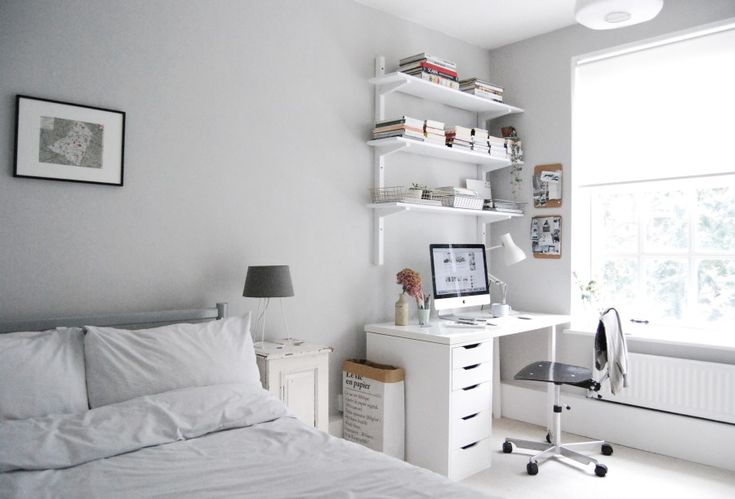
{"left": 0, "top": 0, "right": 498, "bottom": 411}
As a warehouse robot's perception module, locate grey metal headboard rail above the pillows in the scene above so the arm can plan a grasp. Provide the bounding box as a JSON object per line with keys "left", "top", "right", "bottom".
{"left": 0, "top": 302, "right": 227, "bottom": 333}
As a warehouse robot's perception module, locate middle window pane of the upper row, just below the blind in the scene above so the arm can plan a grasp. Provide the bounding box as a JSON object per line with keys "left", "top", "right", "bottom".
{"left": 643, "top": 191, "right": 689, "bottom": 252}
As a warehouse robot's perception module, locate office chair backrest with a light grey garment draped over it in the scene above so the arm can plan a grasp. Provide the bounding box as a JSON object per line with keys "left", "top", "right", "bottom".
{"left": 595, "top": 308, "right": 629, "bottom": 395}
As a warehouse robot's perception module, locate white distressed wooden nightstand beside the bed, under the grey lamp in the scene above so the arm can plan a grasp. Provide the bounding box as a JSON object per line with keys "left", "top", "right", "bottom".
{"left": 255, "top": 338, "right": 332, "bottom": 431}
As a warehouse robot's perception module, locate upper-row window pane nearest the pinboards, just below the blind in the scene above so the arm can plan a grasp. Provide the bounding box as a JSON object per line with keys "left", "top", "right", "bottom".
{"left": 592, "top": 192, "right": 638, "bottom": 253}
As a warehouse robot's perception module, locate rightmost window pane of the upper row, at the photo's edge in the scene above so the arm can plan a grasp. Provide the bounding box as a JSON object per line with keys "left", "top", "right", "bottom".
{"left": 696, "top": 187, "right": 735, "bottom": 251}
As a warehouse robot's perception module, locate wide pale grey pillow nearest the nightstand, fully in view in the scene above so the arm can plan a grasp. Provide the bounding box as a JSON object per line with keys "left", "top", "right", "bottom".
{"left": 84, "top": 313, "right": 261, "bottom": 408}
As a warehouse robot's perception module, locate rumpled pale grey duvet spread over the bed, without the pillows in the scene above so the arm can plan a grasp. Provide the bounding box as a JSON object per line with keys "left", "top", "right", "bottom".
{"left": 0, "top": 385, "right": 494, "bottom": 499}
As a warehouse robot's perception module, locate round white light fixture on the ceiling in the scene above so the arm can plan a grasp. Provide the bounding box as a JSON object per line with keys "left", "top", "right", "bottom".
{"left": 574, "top": 0, "right": 664, "bottom": 29}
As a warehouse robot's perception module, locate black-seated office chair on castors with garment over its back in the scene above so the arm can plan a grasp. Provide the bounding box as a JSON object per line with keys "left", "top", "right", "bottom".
{"left": 503, "top": 308, "right": 627, "bottom": 477}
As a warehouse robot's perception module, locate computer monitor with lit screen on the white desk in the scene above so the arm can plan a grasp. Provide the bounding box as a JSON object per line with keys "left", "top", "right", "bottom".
{"left": 429, "top": 244, "right": 490, "bottom": 310}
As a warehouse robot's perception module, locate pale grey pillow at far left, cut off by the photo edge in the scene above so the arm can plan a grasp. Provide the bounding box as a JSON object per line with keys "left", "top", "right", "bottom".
{"left": 0, "top": 328, "right": 88, "bottom": 419}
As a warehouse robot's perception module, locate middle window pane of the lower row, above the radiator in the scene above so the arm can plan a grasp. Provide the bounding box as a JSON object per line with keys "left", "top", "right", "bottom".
{"left": 641, "top": 258, "right": 687, "bottom": 322}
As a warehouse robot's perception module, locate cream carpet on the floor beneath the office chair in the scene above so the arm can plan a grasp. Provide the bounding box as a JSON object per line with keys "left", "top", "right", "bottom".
{"left": 462, "top": 419, "right": 735, "bottom": 499}
